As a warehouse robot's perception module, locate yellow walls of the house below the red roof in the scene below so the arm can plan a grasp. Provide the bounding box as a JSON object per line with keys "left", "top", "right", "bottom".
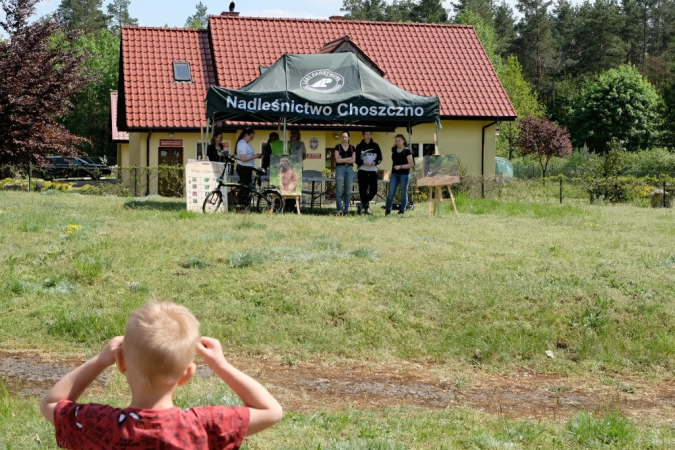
{"left": 125, "top": 120, "right": 495, "bottom": 195}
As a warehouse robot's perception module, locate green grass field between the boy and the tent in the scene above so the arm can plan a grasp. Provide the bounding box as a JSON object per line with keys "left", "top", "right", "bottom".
{"left": 0, "top": 192, "right": 675, "bottom": 450}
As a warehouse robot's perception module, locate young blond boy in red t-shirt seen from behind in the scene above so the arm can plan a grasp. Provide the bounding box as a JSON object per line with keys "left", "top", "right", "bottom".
{"left": 40, "top": 302, "right": 282, "bottom": 450}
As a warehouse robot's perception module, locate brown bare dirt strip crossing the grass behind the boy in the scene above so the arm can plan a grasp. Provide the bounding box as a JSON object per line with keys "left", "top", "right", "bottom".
{"left": 0, "top": 352, "right": 675, "bottom": 422}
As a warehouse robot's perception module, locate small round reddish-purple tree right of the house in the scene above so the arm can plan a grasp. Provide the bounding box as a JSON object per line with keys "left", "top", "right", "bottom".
{"left": 518, "top": 117, "right": 572, "bottom": 178}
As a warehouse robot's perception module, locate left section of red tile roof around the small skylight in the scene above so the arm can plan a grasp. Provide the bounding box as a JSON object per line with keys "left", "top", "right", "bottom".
{"left": 119, "top": 27, "right": 216, "bottom": 130}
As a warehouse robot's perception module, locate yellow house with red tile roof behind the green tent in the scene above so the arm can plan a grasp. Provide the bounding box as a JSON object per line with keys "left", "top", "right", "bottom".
{"left": 117, "top": 12, "right": 516, "bottom": 193}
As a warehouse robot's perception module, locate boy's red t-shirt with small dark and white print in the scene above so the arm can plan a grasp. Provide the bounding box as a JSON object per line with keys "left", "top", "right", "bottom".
{"left": 54, "top": 400, "right": 250, "bottom": 450}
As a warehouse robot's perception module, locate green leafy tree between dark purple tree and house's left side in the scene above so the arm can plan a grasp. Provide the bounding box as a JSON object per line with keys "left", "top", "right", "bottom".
{"left": 63, "top": 30, "right": 120, "bottom": 160}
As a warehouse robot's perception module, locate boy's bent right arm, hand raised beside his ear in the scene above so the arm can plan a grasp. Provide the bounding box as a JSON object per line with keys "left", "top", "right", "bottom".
{"left": 197, "top": 337, "right": 283, "bottom": 436}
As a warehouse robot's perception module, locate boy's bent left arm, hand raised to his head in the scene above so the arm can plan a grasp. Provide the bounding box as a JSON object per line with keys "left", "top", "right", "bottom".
{"left": 40, "top": 336, "right": 124, "bottom": 425}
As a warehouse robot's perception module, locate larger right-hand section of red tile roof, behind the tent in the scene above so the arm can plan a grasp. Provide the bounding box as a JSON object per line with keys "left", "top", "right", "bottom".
{"left": 209, "top": 16, "right": 516, "bottom": 118}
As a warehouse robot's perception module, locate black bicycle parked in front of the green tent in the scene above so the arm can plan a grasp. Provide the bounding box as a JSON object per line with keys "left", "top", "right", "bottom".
{"left": 202, "top": 155, "right": 284, "bottom": 214}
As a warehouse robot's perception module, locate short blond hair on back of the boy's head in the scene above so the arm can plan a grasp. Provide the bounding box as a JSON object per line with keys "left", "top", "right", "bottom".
{"left": 122, "top": 302, "right": 199, "bottom": 383}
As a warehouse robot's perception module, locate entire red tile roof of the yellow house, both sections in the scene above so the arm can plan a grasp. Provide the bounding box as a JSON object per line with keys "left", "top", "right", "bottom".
{"left": 118, "top": 15, "right": 516, "bottom": 130}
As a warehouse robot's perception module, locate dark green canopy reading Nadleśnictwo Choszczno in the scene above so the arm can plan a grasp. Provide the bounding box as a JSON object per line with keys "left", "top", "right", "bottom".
{"left": 206, "top": 52, "right": 440, "bottom": 128}
